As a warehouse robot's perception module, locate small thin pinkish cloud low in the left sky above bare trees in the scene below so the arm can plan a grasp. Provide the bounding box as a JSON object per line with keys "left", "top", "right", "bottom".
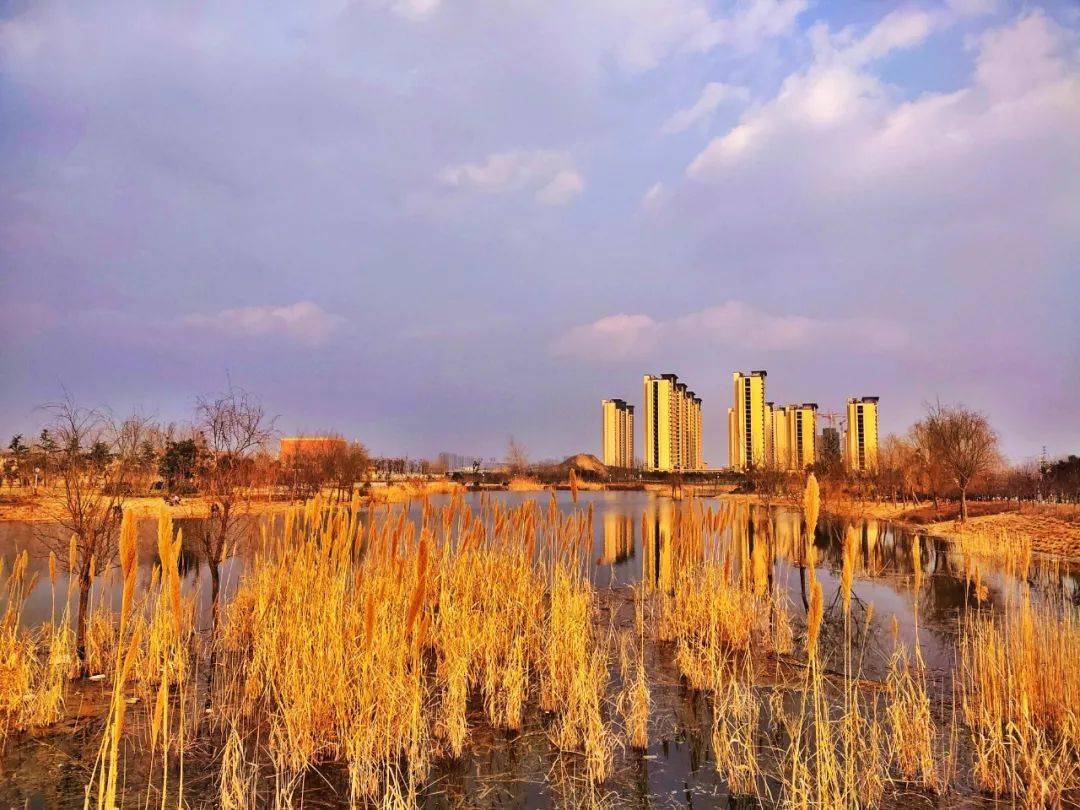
{"left": 183, "top": 301, "right": 346, "bottom": 346}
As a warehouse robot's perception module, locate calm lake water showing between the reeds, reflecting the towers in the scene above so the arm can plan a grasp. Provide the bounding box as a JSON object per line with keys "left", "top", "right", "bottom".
{"left": 0, "top": 491, "right": 1080, "bottom": 807}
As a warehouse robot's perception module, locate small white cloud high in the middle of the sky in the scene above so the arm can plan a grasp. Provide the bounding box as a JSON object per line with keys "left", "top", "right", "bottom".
{"left": 438, "top": 150, "right": 585, "bottom": 205}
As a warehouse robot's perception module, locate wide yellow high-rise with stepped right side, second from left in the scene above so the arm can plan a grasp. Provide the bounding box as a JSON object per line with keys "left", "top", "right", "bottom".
{"left": 644, "top": 374, "right": 704, "bottom": 471}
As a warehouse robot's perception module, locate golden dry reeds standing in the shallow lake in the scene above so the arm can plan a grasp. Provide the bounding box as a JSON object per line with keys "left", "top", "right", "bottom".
{"left": 0, "top": 486, "right": 1080, "bottom": 808}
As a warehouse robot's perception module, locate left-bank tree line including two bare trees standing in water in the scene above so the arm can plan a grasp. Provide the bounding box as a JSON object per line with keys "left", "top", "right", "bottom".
{"left": 0, "top": 388, "right": 370, "bottom": 674}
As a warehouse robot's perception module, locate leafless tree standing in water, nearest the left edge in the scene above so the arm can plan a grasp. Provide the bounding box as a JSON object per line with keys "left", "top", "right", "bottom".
{"left": 44, "top": 396, "right": 147, "bottom": 677}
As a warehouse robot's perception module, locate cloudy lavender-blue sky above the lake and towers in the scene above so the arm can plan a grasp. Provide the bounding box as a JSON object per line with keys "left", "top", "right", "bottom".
{"left": 0, "top": 0, "right": 1080, "bottom": 465}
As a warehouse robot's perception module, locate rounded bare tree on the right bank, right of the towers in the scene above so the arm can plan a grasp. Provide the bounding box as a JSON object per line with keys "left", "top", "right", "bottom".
{"left": 916, "top": 403, "right": 1001, "bottom": 523}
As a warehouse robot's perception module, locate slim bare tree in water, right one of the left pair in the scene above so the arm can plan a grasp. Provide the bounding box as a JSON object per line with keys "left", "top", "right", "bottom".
{"left": 194, "top": 388, "right": 273, "bottom": 630}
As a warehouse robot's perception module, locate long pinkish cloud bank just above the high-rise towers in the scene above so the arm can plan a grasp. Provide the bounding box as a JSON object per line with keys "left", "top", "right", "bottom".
{"left": 552, "top": 300, "right": 908, "bottom": 361}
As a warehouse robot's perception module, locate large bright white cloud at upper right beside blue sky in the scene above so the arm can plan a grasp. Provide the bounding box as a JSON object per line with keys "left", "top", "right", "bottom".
{"left": 687, "top": 13, "right": 1080, "bottom": 182}
